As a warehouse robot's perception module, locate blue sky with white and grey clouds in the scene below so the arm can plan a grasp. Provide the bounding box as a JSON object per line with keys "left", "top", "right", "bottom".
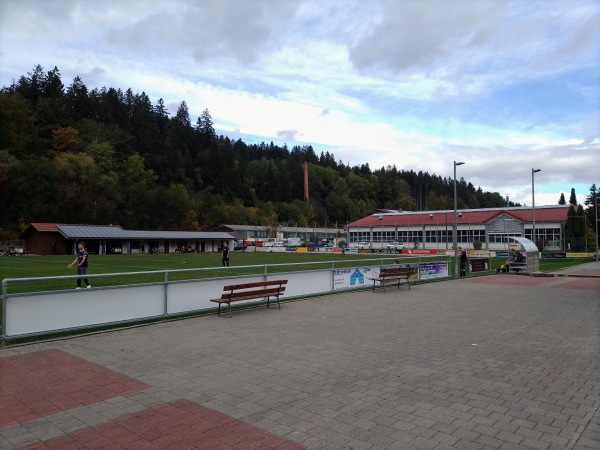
{"left": 0, "top": 0, "right": 600, "bottom": 205}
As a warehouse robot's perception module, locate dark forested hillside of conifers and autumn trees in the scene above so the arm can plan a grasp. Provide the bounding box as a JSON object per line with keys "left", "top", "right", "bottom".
{"left": 0, "top": 65, "right": 504, "bottom": 231}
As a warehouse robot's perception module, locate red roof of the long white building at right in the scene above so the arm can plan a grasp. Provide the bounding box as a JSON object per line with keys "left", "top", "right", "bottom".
{"left": 348, "top": 206, "right": 569, "bottom": 227}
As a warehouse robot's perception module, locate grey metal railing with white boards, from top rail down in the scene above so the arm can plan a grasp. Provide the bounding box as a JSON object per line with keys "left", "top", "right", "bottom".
{"left": 1, "top": 254, "right": 450, "bottom": 342}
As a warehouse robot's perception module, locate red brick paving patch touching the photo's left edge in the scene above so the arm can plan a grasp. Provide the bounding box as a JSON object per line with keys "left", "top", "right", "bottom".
{"left": 0, "top": 350, "right": 149, "bottom": 428}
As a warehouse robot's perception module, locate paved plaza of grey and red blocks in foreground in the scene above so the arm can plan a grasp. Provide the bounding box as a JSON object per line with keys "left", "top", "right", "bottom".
{"left": 0, "top": 263, "right": 600, "bottom": 450}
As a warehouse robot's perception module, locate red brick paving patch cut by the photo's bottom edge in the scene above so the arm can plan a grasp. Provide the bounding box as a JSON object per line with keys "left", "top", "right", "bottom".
{"left": 26, "top": 400, "right": 304, "bottom": 450}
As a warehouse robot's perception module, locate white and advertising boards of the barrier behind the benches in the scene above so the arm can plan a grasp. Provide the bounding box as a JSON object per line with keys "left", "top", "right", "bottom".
{"left": 2, "top": 257, "right": 449, "bottom": 341}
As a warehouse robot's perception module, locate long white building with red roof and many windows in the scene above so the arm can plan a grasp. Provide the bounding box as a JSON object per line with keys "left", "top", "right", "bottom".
{"left": 347, "top": 205, "right": 569, "bottom": 251}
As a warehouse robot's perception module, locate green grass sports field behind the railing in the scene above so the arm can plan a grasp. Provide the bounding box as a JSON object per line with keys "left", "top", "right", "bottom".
{"left": 0, "top": 251, "right": 590, "bottom": 294}
